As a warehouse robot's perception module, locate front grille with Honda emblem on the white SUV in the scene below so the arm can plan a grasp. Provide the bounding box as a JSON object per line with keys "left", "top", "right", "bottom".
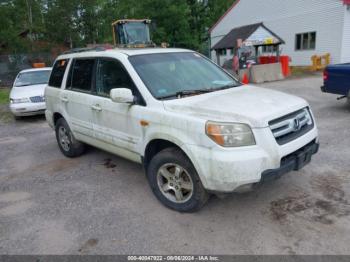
{"left": 269, "top": 108, "right": 314, "bottom": 145}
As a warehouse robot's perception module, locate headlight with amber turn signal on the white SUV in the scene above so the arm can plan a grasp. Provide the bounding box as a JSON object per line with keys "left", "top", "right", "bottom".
{"left": 205, "top": 121, "right": 256, "bottom": 147}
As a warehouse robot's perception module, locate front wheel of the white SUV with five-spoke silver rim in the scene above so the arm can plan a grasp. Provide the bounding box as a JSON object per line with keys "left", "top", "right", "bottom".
{"left": 147, "top": 148, "right": 209, "bottom": 212}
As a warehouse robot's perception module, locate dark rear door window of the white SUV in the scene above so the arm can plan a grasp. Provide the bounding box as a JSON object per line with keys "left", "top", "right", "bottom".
{"left": 67, "top": 59, "right": 95, "bottom": 93}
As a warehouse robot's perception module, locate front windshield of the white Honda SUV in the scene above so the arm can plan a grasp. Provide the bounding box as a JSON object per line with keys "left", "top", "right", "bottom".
{"left": 129, "top": 52, "right": 240, "bottom": 99}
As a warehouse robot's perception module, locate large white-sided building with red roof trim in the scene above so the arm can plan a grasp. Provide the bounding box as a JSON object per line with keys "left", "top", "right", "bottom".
{"left": 210, "top": 0, "right": 350, "bottom": 66}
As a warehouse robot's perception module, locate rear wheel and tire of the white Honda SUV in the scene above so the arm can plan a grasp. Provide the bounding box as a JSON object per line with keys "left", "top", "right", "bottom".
{"left": 55, "top": 118, "right": 85, "bottom": 158}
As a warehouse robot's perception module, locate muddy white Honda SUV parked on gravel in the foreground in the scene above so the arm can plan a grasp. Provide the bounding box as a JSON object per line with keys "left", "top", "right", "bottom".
{"left": 45, "top": 48, "right": 318, "bottom": 212}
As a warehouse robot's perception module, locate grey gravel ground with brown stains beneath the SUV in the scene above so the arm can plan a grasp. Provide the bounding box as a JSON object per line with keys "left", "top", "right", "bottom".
{"left": 0, "top": 76, "right": 350, "bottom": 254}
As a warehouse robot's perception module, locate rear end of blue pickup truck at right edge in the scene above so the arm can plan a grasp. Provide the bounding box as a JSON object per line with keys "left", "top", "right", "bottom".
{"left": 321, "top": 63, "right": 350, "bottom": 103}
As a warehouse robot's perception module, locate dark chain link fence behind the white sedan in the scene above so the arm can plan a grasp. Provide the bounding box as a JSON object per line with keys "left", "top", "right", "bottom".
{"left": 0, "top": 52, "right": 55, "bottom": 87}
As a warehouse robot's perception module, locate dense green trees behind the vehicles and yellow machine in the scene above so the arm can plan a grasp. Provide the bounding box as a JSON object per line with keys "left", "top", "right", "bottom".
{"left": 0, "top": 0, "right": 234, "bottom": 52}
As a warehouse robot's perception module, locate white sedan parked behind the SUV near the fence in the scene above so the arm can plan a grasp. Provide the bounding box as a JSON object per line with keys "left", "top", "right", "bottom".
{"left": 10, "top": 67, "right": 52, "bottom": 118}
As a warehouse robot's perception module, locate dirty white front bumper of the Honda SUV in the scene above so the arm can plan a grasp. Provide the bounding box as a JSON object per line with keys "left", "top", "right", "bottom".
{"left": 183, "top": 125, "right": 318, "bottom": 193}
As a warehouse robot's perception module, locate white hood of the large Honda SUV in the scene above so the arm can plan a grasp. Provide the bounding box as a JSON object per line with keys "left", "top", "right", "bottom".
{"left": 163, "top": 85, "right": 308, "bottom": 128}
